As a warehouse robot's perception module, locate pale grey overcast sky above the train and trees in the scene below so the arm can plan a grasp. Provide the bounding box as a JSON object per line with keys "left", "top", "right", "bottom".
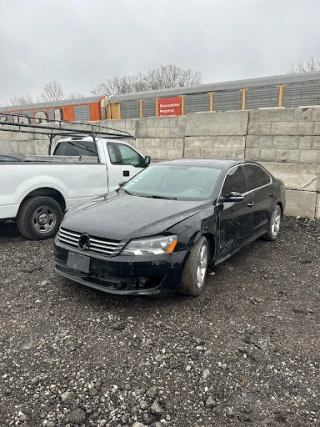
{"left": 0, "top": 0, "right": 320, "bottom": 104}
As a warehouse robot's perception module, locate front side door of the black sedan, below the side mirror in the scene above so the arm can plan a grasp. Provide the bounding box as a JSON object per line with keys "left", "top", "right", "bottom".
{"left": 218, "top": 165, "right": 253, "bottom": 258}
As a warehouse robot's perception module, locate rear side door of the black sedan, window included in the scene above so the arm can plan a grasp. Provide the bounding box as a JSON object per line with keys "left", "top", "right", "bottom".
{"left": 244, "top": 164, "right": 274, "bottom": 236}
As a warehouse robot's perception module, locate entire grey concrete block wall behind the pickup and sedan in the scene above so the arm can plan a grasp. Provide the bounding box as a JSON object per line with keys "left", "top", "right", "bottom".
{"left": 0, "top": 107, "right": 320, "bottom": 218}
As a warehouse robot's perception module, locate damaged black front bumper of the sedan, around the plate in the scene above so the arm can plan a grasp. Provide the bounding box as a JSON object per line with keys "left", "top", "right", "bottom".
{"left": 54, "top": 239, "right": 188, "bottom": 295}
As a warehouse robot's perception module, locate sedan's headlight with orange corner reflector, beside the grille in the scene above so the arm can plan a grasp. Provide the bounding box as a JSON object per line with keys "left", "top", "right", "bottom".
{"left": 122, "top": 236, "right": 178, "bottom": 255}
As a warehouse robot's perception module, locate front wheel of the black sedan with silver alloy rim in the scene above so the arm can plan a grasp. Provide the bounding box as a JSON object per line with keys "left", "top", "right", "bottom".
{"left": 179, "top": 237, "right": 209, "bottom": 297}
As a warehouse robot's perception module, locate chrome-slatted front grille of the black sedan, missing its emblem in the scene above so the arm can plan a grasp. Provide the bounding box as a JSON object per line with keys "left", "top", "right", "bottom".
{"left": 58, "top": 227, "right": 124, "bottom": 256}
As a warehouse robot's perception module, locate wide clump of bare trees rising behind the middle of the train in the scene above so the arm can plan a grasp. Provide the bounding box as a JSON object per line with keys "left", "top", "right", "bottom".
{"left": 91, "top": 65, "right": 202, "bottom": 95}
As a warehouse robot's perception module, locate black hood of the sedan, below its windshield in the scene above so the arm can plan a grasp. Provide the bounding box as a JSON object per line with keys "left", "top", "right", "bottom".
{"left": 61, "top": 192, "right": 208, "bottom": 240}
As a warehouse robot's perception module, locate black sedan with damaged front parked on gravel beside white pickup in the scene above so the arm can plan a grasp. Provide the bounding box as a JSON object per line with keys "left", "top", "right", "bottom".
{"left": 54, "top": 159, "right": 285, "bottom": 296}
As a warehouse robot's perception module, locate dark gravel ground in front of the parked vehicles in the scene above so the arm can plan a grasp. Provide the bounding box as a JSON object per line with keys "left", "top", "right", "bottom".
{"left": 0, "top": 218, "right": 320, "bottom": 427}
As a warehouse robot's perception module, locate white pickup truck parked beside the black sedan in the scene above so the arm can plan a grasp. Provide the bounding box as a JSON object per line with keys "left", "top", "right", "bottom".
{"left": 0, "top": 136, "right": 150, "bottom": 240}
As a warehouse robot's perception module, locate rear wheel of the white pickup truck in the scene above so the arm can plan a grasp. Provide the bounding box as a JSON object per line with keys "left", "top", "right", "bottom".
{"left": 17, "top": 196, "right": 63, "bottom": 240}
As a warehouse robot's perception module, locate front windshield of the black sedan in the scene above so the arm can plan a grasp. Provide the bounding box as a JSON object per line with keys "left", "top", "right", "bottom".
{"left": 122, "top": 165, "right": 221, "bottom": 200}
